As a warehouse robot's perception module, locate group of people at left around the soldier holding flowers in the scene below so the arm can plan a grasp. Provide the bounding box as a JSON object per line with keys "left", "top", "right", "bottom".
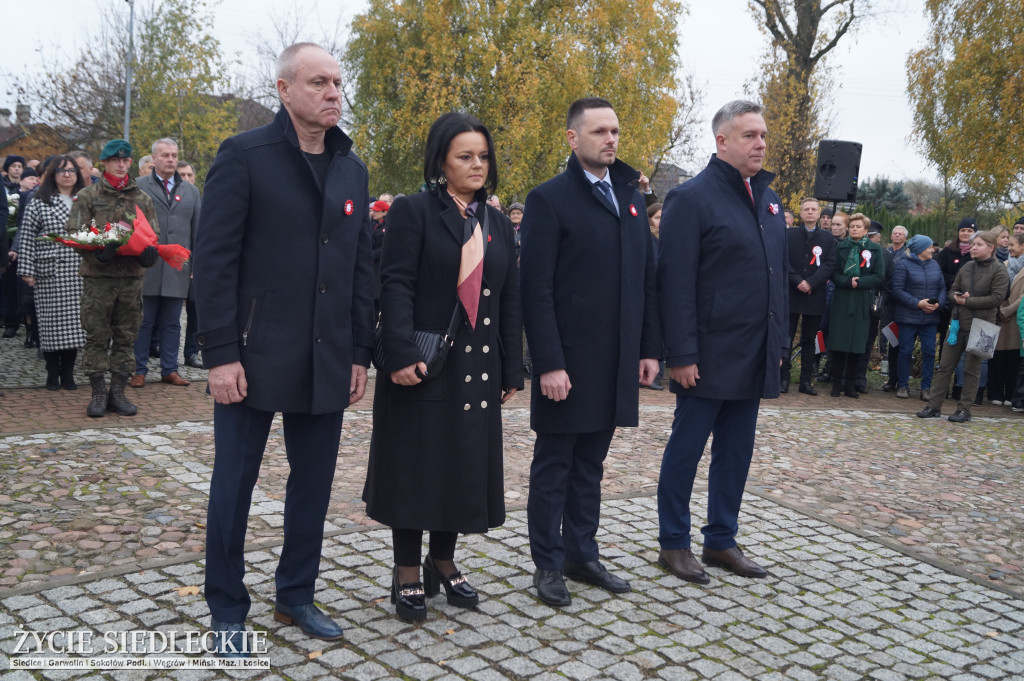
{"left": 0, "top": 138, "right": 202, "bottom": 418}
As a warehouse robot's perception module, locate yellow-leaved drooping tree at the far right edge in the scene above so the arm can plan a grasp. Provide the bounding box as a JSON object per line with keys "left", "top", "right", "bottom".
{"left": 907, "top": 0, "right": 1024, "bottom": 205}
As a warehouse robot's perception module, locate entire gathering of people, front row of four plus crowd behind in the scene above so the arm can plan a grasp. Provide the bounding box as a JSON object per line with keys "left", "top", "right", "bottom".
{"left": 4, "top": 43, "right": 1024, "bottom": 656}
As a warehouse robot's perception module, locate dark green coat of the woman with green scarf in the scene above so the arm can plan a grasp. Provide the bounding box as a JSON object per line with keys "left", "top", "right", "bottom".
{"left": 828, "top": 239, "right": 886, "bottom": 353}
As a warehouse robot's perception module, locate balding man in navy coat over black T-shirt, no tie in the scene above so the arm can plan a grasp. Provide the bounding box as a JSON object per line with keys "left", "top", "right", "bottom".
{"left": 195, "top": 43, "right": 373, "bottom": 655}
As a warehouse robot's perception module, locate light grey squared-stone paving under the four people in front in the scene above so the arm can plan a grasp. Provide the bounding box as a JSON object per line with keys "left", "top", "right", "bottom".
{"left": 0, "top": 497, "right": 1024, "bottom": 681}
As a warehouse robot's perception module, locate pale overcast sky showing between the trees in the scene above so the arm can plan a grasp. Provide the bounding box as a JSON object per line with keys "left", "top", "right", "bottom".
{"left": 0, "top": 0, "right": 935, "bottom": 180}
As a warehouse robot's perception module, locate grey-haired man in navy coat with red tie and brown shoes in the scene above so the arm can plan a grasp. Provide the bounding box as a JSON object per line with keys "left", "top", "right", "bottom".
{"left": 657, "top": 100, "right": 790, "bottom": 584}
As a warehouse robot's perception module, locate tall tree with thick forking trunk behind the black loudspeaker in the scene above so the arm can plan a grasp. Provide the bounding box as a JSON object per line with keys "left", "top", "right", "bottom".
{"left": 750, "top": 0, "right": 867, "bottom": 205}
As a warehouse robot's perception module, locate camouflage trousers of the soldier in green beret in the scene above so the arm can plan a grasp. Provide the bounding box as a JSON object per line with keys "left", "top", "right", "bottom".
{"left": 82, "top": 276, "right": 142, "bottom": 375}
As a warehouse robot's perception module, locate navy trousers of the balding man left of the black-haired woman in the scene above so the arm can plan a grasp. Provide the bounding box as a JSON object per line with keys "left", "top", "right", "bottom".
{"left": 206, "top": 403, "right": 344, "bottom": 622}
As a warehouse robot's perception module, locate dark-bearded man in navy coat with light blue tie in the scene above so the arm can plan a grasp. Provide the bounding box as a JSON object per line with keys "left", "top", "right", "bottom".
{"left": 520, "top": 97, "right": 660, "bottom": 605}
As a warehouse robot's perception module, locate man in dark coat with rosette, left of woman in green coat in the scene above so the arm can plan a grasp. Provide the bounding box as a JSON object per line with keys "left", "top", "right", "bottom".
{"left": 779, "top": 198, "right": 836, "bottom": 395}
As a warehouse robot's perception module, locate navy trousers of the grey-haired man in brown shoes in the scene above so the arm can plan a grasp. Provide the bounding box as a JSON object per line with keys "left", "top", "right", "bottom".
{"left": 657, "top": 394, "right": 761, "bottom": 551}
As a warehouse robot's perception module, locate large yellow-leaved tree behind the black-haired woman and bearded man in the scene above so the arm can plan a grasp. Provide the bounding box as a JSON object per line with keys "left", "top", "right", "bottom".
{"left": 344, "top": 0, "right": 695, "bottom": 202}
